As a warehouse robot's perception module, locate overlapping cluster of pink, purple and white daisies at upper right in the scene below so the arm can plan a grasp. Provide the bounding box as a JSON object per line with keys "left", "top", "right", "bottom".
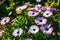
{"left": 28, "top": 4, "right": 56, "bottom": 18}
